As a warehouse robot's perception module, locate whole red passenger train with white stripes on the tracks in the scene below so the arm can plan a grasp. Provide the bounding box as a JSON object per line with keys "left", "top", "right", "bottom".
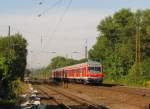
{"left": 50, "top": 61, "right": 104, "bottom": 84}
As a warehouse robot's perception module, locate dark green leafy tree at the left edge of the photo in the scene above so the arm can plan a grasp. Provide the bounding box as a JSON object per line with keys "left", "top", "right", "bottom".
{"left": 0, "top": 33, "right": 27, "bottom": 99}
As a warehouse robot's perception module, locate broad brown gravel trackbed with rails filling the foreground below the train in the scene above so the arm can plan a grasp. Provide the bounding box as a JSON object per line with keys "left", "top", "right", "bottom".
{"left": 31, "top": 83, "right": 150, "bottom": 109}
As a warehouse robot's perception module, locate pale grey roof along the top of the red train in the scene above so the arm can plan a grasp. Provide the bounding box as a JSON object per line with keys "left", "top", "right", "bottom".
{"left": 53, "top": 61, "right": 101, "bottom": 71}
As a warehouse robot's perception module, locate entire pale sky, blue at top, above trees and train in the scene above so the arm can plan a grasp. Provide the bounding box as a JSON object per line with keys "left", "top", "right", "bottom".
{"left": 0, "top": 0, "right": 150, "bottom": 68}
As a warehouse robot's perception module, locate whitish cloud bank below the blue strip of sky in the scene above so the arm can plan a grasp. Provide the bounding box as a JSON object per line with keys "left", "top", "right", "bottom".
{"left": 0, "top": 10, "right": 110, "bottom": 67}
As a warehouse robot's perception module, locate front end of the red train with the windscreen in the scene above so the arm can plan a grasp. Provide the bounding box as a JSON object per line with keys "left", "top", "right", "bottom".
{"left": 87, "top": 61, "right": 104, "bottom": 84}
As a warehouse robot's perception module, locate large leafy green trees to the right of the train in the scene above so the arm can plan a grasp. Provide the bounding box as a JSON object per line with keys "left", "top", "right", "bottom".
{"left": 89, "top": 9, "right": 150, "bottom": 84}
